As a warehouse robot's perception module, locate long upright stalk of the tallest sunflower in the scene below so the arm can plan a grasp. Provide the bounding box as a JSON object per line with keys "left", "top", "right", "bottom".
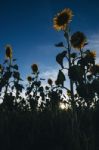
{"left": 64, "top": 31, "right": 80, "bottom": 150}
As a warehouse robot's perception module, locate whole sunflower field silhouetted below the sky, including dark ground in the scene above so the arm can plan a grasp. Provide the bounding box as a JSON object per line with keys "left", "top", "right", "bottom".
{"left": 0, "top": 9, "right": 99, "bottom": 150}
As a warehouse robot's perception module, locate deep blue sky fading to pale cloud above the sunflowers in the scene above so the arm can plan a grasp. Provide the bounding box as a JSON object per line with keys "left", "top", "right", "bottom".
{"left": 0, "top": 0, "right": 99, "bottom": 81}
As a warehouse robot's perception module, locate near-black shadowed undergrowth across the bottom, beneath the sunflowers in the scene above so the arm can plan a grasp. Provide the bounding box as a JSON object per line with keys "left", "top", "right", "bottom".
{"left": 0, "top": 108, "right": 99, "bottom": 150}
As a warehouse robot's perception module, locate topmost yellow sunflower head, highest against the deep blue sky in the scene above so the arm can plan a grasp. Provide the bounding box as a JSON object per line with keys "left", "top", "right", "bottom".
{"left": 53, "top": 8, "right": 73, "bottom": 31}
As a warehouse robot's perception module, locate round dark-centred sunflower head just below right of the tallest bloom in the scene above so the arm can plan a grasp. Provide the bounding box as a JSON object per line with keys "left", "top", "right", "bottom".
{"left": 71, "top": 31, "right": 87, "bottom": 49}
